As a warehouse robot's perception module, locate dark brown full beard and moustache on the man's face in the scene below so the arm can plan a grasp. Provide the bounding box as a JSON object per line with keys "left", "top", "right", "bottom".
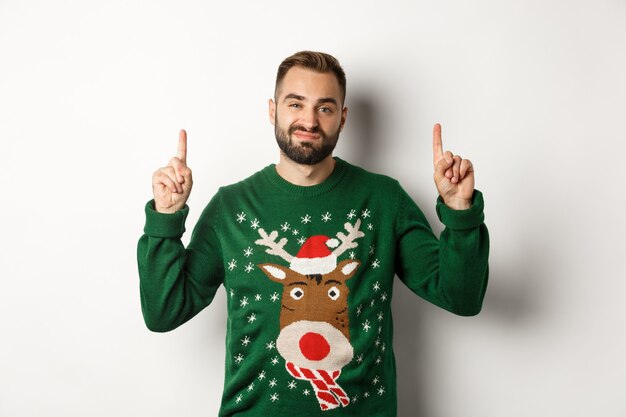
{"left": 274, "top": 117, "right": 339, "bottom": 165}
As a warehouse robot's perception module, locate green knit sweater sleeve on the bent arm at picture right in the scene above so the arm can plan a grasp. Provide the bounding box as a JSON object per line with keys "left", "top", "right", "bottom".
{"left": 396, "top": 186, "right": 489, "bottom": 316}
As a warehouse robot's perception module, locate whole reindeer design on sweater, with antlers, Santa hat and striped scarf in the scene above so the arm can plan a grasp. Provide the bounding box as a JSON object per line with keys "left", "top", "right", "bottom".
{"left": 255, "top": 219, "right": 364, "bottom": 411}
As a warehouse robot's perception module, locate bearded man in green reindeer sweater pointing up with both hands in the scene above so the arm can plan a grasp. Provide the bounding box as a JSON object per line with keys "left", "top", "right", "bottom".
{"left": 138, "top": 51, "right": 489, "bottom": 417}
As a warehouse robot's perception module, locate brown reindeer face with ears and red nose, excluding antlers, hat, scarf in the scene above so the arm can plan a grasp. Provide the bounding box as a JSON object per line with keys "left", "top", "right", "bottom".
{"left": 259, "top": 259, "right": 360, "bottom": 369}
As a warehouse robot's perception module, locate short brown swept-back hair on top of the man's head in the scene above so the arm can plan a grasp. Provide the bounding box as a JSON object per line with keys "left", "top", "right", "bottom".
{"left": 274, "top": 51, "right": 346, "bottom": 102}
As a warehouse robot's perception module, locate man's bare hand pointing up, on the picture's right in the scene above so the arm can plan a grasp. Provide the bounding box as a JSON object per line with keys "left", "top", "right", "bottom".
{"left": 433, "top": 123, "right": 474, "bottom": 210}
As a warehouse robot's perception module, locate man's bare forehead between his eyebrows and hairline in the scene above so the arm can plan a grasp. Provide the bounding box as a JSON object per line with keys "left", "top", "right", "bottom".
{"left": 277, "top": 67, "right": 341, "bottom": 102}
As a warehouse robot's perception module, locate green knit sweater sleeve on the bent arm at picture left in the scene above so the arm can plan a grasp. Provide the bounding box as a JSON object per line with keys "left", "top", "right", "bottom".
{"left": 137, "top": 194, "right": 224, "bottom": 332}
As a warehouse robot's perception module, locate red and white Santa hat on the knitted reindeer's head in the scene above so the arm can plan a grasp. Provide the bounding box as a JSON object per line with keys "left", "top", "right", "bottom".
{"left": 289, "top": 235, "right": 339, "bottom": 275}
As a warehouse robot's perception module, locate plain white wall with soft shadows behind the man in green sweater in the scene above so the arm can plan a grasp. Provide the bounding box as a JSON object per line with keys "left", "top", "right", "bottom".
{"left": 0, "top": 0, "right": 626, "bottom": 417}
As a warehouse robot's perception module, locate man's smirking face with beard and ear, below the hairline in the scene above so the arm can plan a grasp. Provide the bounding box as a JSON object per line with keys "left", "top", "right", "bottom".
{"left": 269, "top": 67, "right": 348, "bottom": 165}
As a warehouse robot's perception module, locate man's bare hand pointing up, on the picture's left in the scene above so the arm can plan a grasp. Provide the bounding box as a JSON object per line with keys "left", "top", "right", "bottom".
{"left": 152, "top": 129, "right": 193, "bottom": 213}
